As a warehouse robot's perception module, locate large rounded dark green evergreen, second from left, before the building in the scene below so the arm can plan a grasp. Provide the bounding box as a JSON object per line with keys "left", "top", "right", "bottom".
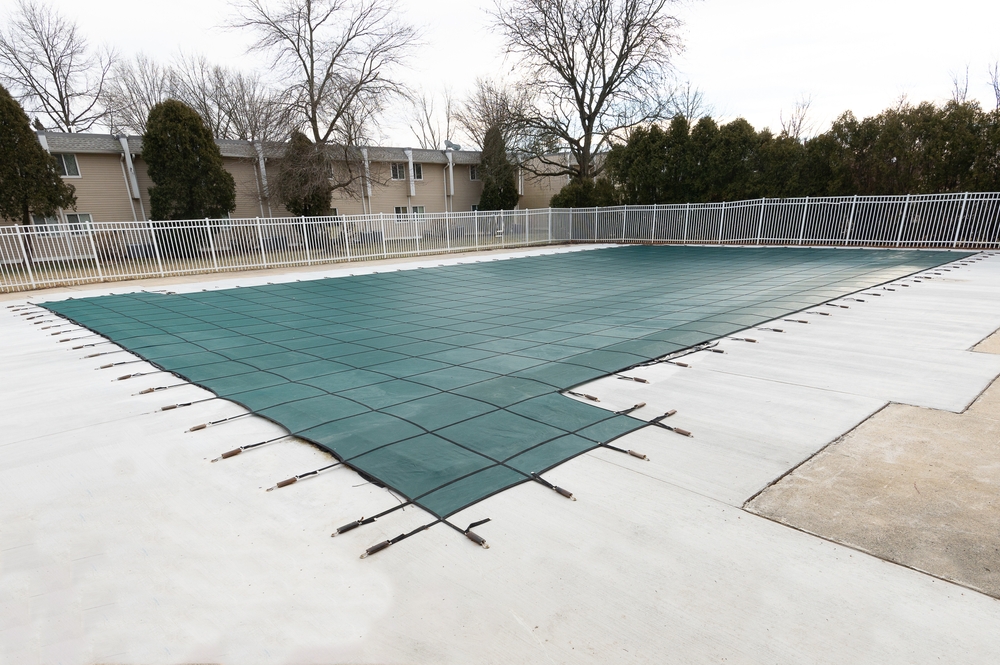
{"left": 142, "top": 99, "right": 236, "bottom": 220}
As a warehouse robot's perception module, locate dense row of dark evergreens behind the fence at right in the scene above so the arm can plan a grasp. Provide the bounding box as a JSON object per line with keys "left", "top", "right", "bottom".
{"left": 552, "top": 102, "right": 1000, "bottom": 206}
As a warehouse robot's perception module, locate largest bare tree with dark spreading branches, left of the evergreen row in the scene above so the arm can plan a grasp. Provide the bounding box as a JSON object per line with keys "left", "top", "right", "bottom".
{"left": 493, "top": 0, "right": 680, "bottom": 179}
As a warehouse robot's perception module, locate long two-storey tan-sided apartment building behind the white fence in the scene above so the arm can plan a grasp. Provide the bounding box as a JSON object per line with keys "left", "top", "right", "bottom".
{"left": 7, "top": 132, "right": 566, "bottom": 225}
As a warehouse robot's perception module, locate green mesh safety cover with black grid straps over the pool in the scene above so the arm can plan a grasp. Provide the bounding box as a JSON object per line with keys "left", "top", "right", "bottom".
{"left": 45, "top": 246, "right": 966, "bottom": 518}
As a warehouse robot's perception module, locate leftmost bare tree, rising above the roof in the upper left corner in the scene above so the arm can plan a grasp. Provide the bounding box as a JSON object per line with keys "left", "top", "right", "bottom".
{"left": 0, "top": 0, "right": 115, "bottom": 132}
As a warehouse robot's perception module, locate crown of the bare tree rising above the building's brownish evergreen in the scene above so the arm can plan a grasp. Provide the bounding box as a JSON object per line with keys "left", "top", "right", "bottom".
{"left": 230, "top": 0, "right": 417, "bottom": 145}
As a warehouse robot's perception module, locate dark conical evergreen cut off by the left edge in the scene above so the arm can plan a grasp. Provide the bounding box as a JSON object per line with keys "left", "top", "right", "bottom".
{"left": 0, "top": 86, "right": 76, "bottom": 225}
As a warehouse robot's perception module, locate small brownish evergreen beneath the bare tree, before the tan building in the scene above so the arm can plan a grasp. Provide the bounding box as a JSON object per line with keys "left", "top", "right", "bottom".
{"left": 274, "top": 132, "right": 333, "bottom": 217}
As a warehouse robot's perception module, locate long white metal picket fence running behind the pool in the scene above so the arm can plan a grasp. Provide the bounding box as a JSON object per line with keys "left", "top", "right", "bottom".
{"left": 0, "top": 193, "right": 1000, "bottom": 292}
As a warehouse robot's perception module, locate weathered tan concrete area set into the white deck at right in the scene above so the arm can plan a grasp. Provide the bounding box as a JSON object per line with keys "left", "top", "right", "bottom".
{"left": 746, "top": 352, "right": 1000, "bottom": 598}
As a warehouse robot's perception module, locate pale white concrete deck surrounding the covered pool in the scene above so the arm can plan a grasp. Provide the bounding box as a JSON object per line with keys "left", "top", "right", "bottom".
{"left": 0, "top": 245, "right": 1000, "bottom": 663}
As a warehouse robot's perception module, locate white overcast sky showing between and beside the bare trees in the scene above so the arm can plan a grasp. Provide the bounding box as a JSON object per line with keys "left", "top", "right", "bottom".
{"left": 50, "top": 0, "right": 1000, "bottom": 145}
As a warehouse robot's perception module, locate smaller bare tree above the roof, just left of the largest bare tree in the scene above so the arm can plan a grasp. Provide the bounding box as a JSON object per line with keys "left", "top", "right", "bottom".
{"left": 455, "top": 79, "right": 532, "bottom": 153}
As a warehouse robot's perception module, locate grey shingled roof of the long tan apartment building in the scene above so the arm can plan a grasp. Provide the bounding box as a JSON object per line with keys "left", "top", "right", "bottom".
{"left": 44, "top": 132, "right": 480, "bottom": 164}
